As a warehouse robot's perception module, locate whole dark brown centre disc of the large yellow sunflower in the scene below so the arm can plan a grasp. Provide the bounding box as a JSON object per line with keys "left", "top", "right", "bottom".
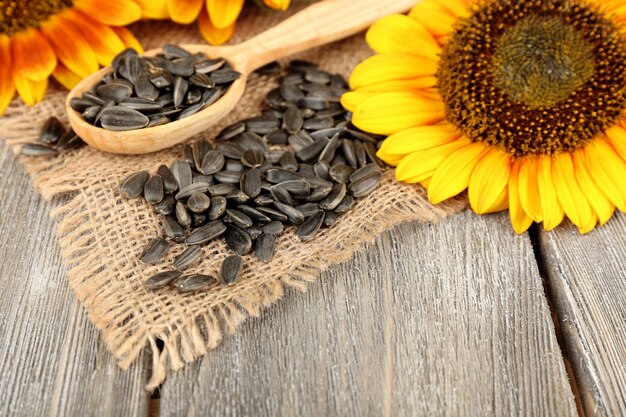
{"left": 437, "top": 0, "right": 626, "bottom": 156}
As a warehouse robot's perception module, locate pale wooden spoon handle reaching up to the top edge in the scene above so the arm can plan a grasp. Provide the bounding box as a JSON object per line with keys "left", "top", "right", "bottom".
{"left": 234, "top": 0, "right": 417, "bottom": 72}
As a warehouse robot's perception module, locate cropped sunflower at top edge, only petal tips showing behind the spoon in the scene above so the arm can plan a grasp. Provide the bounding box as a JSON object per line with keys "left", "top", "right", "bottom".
{"left": 158, "top": 0, "right": 291, "bottom": 45}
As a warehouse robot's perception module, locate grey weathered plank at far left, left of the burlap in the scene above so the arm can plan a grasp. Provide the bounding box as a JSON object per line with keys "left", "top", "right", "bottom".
{"left": 0, "top": 144, "right": 149, "bottom": 417}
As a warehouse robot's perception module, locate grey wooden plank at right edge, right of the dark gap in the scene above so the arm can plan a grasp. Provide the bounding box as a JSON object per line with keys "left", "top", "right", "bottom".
{"left": 540, "top": 213, "right": 626, "bottom": 417}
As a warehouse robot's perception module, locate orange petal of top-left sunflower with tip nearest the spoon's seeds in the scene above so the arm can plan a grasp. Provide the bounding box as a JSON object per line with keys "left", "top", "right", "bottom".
{"left": 65, "top": 9, "right": 124, "bottom": 66}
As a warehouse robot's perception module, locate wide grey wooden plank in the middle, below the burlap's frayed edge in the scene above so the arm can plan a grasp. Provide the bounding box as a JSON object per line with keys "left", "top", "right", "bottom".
{"left": 160, "top": 213, "right": 577, "bottom": 417}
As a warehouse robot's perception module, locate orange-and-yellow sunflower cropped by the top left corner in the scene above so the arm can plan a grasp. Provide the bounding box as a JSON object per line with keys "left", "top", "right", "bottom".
{"left": 0, "top": 0, "right": 142, "bottom": 114}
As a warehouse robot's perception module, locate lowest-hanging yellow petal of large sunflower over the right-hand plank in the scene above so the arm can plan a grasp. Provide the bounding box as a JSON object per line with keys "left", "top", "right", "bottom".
{"left": 552, "top": 152, "right": 597, "bottom": 234}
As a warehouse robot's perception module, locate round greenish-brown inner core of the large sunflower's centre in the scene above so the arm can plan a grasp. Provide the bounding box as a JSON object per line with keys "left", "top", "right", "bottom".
{"left": 493, "top": 16, "right": 595, "bottom": 107}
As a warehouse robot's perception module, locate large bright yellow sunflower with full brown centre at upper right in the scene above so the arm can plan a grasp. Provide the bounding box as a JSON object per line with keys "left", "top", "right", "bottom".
{"left": 342, "top": 0, "right": 626, "bottom": 233}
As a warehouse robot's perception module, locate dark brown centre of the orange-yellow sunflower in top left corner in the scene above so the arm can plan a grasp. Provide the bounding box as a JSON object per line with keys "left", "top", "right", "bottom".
{"left": 0, "top": 0, "right": 72, "bottom": 36}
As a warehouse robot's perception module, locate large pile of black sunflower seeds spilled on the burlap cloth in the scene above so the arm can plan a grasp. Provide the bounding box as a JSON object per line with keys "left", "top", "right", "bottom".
{"left": 119, "top": 61, "right": 384, "bottom": 292}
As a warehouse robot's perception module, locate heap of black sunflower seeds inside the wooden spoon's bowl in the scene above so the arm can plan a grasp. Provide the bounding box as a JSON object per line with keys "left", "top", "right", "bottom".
{"left": 70, "top": 44, "right": 241, "bottom": 131}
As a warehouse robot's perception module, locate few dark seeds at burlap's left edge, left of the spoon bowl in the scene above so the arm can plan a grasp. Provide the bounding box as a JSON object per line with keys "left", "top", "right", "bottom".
{"left": 20, "top": 117, "right": 85, "bottom": 156}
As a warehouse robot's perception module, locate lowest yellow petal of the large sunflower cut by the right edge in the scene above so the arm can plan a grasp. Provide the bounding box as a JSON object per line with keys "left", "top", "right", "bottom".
{"left": 585, "top": 140, "right": 626, "bottom": 211}
